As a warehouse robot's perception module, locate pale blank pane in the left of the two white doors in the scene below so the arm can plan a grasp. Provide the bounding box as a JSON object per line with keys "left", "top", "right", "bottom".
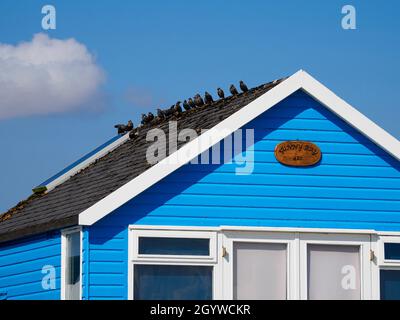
{"left": 233, "top": 242, "right": 287, "bottom": 300}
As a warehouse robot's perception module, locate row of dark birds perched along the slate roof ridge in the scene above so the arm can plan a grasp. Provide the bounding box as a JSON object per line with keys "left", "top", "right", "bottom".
{"left": 114, "top": 81, "right": 249, "bottom": 138}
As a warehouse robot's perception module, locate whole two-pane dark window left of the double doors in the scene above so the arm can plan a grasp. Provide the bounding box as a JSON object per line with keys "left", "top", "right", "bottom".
{"left": 130, "top": 229, "right": 217, "bottom": 300}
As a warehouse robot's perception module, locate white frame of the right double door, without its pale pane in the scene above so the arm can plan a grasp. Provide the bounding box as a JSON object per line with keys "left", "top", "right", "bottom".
{"left": 299, "top": 233, "right": 373, "bottom": 300}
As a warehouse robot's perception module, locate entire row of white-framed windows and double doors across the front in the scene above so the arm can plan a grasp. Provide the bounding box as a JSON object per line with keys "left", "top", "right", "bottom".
{"left": 128, "top": 226, "right": 382, "bottom": 300}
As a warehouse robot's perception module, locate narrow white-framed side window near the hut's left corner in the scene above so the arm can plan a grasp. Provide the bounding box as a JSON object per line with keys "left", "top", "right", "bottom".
{"left": 62, "top": 229, "right": 82, "bottom": 300}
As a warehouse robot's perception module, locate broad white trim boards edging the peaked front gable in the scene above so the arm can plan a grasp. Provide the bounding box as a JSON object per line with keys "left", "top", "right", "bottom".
{"left": 79, "top": 70, "right": 400, "bottom": 225}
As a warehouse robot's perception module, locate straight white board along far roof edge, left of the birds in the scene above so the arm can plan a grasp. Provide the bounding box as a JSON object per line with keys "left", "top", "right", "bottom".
{"left": 45, "top": 134, "right": 129, "bottom": 192}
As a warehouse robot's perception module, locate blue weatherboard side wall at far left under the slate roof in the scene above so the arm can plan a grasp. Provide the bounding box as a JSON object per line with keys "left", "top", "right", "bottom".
{"left": 0, "top": 233, "right": 61, "bottom": 300}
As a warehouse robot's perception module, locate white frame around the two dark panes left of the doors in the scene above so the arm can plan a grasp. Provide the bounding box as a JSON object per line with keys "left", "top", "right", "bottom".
{"left": 128, "top": 225, "right": 221, "bottom": 300}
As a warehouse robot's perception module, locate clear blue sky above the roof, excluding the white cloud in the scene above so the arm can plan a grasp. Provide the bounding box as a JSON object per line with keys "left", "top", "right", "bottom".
{"left": 0, "top": 0, "right": 400, "bottom": 212}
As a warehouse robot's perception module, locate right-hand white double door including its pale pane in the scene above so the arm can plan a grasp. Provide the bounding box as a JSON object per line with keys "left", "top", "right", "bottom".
{"left": 299, "top": 233, "right": 371, "bottom": 300}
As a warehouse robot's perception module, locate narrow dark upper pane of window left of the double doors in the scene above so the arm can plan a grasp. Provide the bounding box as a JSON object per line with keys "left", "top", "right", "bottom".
{"left": 139, "top": 237, "right": 210, "bottom": 256}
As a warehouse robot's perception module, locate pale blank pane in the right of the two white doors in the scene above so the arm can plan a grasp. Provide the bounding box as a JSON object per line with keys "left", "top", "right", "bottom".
{"left": 307, "top": 244, "right": 361, "bottom": 300}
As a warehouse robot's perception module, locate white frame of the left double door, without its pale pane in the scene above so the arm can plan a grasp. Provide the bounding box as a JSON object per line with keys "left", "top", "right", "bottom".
{"left": 221, "top": 231, "right": 299, "bottom": 300}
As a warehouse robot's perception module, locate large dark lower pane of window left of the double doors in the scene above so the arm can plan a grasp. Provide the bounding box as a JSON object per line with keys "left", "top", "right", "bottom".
{"left": 134, "top": 265, "right": 212, "bottom": 300}
